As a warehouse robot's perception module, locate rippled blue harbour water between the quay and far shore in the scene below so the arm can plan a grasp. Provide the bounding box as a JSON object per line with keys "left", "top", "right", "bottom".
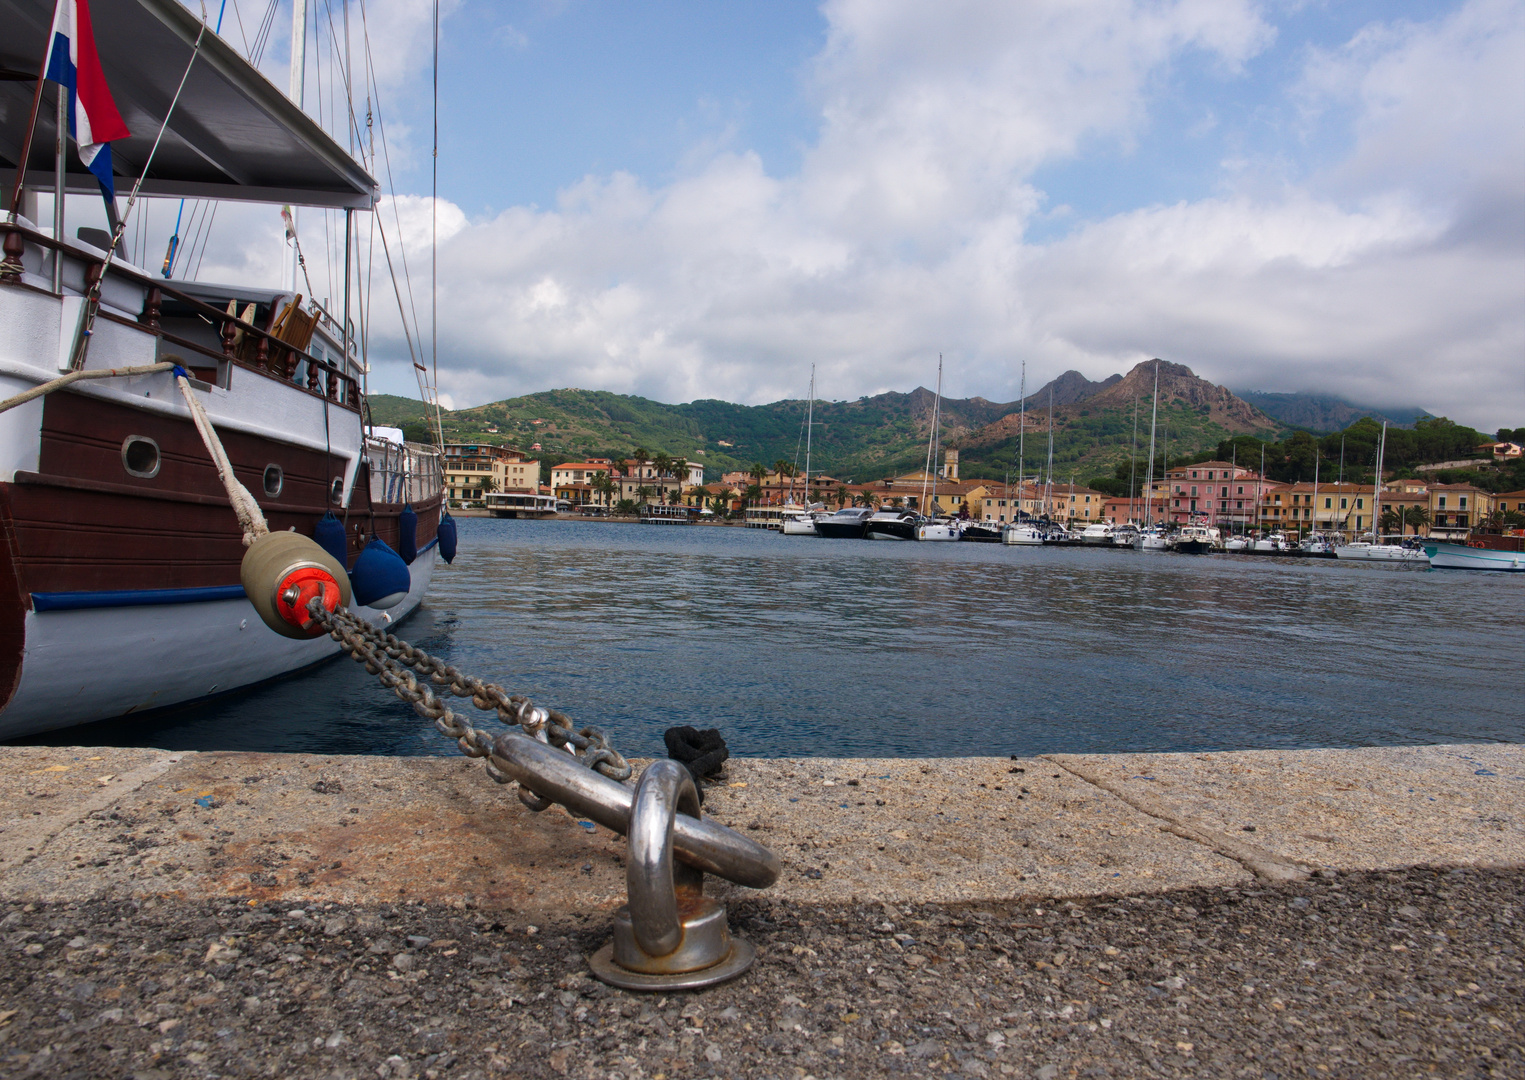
{"left": 23, "top": 519, "right": 1525, "bottom": 755}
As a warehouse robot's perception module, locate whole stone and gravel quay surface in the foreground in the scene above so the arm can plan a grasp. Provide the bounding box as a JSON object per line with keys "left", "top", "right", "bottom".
{"left": 0, "top": 744, "right": 1525, "bottom": 1080}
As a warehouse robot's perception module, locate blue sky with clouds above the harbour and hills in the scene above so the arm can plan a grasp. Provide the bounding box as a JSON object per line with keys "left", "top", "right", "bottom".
{"left": 80, "top": 0, "right": 1525, "bottom": 430}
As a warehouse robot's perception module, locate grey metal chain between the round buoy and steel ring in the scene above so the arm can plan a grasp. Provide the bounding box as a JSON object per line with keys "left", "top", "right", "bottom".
{"left": 308, "top": 598, "right": 633, "bottom": 810}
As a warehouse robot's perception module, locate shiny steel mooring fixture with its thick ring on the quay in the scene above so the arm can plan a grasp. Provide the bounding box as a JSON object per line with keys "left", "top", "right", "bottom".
{"left": 490, "top": 732, "right": 779, "bottom": 990}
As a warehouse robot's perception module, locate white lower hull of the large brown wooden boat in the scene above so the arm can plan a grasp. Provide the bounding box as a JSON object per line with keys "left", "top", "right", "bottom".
{"left": 0, "top": 546, "right": 439, "bottom": 738}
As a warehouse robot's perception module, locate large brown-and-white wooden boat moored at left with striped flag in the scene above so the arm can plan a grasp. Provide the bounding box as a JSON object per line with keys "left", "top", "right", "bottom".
{"left": 0, "top": 0, "right": 454, "bottom": 738}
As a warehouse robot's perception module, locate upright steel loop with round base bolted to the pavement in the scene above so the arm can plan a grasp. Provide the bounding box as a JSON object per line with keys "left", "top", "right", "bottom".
{"left": 589, "top": 761, "right": 756, "bottom": 990}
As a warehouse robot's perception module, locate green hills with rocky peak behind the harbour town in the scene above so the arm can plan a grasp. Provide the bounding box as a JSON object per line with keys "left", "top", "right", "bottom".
{"left": 362, "top": 362, "right": 1281, "bottom": 482}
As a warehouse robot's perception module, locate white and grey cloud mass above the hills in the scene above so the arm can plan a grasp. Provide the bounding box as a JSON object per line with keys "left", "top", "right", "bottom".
{"left": 196, "top": 0, "right": 1525, "bottom": 424}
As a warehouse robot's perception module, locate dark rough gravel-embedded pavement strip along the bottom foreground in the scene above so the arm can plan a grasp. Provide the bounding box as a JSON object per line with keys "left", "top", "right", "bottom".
{"left": 0, "top": 869, "right": 1525, "bottom": 1080}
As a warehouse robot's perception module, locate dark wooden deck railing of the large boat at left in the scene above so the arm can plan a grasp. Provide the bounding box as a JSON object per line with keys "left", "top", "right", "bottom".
{"left": 0, "top": 221, "right": 360, "bottom": 412}
